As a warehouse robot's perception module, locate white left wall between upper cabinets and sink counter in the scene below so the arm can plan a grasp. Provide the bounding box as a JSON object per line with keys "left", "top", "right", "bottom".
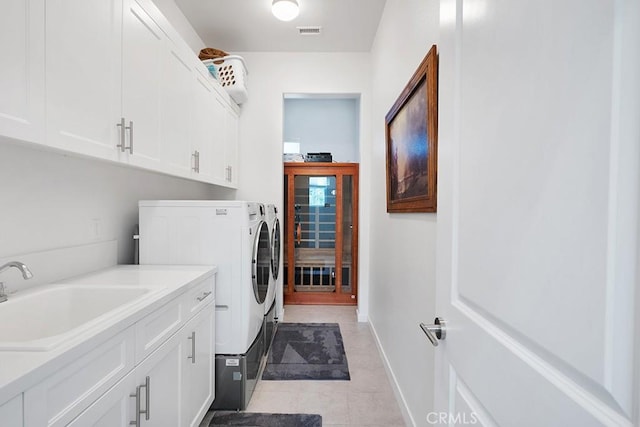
{"left": 0, "top": 138, "right": 233, "bottom": 264}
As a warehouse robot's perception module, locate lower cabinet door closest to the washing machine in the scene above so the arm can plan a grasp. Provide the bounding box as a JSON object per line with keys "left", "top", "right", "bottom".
{"left": 183, "top": 304, "right": 215, "bottom": 427}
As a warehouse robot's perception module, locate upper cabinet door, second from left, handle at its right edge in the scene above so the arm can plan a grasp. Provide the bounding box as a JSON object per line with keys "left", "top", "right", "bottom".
{"left": 44, "top": 0, "right": 122, "bottom": 160}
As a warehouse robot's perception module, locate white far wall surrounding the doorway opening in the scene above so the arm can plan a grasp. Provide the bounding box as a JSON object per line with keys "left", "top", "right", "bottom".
{"left": 237, "top": 52, "right": 372, "bottom": 320}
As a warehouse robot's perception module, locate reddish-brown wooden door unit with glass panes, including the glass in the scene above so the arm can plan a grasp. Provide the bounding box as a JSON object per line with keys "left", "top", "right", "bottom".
{"left": 283, "top": 163, "right": 358, "bottom": 305}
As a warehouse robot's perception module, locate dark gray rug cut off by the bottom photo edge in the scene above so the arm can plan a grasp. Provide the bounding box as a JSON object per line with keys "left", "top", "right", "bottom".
{"left": 208, "top": 411, "right": 322, "bottom": 427}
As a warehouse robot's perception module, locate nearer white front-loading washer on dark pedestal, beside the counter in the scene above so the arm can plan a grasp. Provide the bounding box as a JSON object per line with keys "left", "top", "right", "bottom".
{"left": 139, "top": 200, "right": 271, "bottom": 410}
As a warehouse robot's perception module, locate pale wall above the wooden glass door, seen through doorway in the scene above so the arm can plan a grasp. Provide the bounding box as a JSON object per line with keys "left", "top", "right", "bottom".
{"left": 284, "top": 98, "right": 360, "bottom": 162}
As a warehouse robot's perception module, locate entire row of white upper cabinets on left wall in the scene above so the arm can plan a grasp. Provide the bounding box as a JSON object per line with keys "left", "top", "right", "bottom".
{"left": 6, "top": 0, "right": 237, "bottom": 187}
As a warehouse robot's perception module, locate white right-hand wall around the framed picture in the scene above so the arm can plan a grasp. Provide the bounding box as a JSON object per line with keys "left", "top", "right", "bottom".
{"left": 365, "top": 0, "right": 439, "bottom": 425}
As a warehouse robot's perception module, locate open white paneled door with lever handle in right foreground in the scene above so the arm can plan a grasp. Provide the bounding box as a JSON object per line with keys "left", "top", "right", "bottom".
{"left": 436, "top": 0, "right": 640, "bottom": 427}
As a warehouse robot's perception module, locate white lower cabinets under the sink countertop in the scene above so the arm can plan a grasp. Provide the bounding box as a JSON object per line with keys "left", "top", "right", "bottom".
{"left": 13, "top": 277, "right": 215, "bottom": 427}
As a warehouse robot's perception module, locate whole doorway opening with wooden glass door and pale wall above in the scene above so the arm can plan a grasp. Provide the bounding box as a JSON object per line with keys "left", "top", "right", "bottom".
{"left": 283, "top": 95, "right": 360, "bottom": 305}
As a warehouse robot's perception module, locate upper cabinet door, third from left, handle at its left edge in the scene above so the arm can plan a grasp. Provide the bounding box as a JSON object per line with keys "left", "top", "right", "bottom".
{"left": 122, "top": 0, "right": 162, "bottom": 170}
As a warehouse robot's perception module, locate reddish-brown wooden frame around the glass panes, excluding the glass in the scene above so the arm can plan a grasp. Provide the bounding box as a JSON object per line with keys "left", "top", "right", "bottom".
{"left": 284, "top": 162, "right": 359, "bottom": 305}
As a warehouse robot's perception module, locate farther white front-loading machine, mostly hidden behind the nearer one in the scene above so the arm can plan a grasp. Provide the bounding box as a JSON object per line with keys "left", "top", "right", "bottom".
{"left": 264, "top": 205, "right": 282, "bottom": 354}
